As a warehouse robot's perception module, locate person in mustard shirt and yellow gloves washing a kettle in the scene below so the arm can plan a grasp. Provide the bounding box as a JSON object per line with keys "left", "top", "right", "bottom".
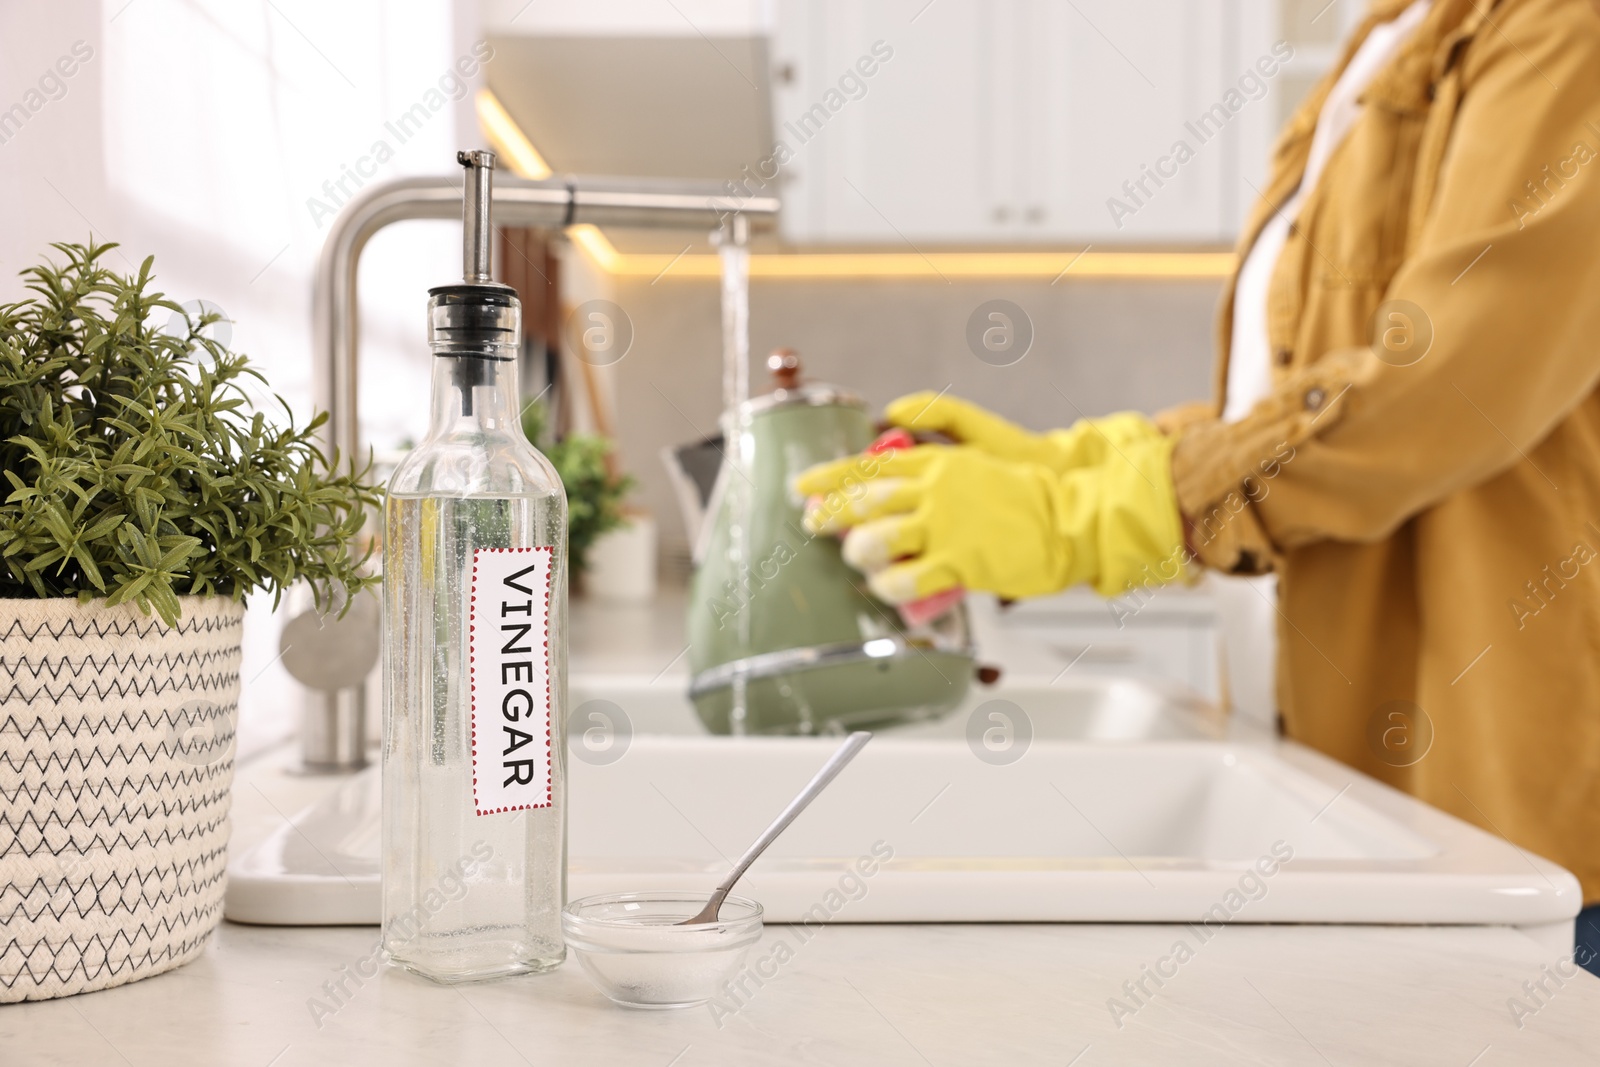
{"left": 800, "top": 0, "right": 1600, "bottom": 963}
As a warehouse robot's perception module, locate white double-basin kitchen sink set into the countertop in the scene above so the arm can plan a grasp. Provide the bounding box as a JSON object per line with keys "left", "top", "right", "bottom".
{"left": 227, "top": 680, "right": 1581, "bottom": 945}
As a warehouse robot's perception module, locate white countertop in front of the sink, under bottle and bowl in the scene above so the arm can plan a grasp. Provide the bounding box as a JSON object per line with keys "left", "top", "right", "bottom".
{"left": 12, "top": 923, "right": 1600, "bottom": 1067}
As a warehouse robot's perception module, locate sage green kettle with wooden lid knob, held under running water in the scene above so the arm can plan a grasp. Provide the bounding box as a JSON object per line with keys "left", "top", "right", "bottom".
{"left": 688, "top": 349, "right": 974, "bottom": 734}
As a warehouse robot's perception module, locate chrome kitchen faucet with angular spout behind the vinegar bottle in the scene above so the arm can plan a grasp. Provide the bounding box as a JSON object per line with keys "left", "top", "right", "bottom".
{"left": 301, "top": 176, "right": 778, "bottom": 773}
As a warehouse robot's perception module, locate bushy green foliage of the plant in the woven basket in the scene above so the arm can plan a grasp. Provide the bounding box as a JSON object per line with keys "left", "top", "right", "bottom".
{"left": 0, "top": 242, "right": 378, "bottom": 624}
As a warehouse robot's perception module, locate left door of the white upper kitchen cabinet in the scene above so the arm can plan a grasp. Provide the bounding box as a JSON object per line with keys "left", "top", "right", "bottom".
{"left": 773, "top": 0, "right": 1002, "bottom": 245}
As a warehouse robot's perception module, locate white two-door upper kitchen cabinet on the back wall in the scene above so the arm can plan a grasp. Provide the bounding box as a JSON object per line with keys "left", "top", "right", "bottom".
{"left": 773, "top": 0, "right": 1277, "bottom": 248}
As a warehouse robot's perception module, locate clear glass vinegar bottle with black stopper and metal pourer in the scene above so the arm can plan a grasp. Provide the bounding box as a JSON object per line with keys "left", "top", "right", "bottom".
{"left": 382, "top": 152, "right": 566, "bottom": 982}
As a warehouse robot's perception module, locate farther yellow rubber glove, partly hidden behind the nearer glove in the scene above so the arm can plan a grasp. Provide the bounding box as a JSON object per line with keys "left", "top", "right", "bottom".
{"left": 883, "top": 392, "right": 1163, "bottom": 474}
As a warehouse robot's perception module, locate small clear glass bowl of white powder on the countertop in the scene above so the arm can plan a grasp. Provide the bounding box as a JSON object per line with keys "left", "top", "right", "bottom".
{"left": 562, "top": 889, "right": 762, "bottom": 1008}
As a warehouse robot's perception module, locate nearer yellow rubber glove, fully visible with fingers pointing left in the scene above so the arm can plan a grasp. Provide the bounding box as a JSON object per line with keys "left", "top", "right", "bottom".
{"left": 795, "top": 437, "right": 1182, "bottom": 603}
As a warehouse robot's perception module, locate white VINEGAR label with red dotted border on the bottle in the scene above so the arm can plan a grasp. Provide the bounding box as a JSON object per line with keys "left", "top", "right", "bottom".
{"left": 467, "top": 545, "right": 555, "bottom": 816}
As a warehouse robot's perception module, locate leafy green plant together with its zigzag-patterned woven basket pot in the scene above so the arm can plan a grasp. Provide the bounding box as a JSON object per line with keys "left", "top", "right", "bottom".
{"left": 0, "top": 243, "right": 378, "bottom": 1001}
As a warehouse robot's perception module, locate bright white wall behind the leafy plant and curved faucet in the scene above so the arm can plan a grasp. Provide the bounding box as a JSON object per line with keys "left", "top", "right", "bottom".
{"left": 0, "top": 0, "right": 489, "bottom": 751}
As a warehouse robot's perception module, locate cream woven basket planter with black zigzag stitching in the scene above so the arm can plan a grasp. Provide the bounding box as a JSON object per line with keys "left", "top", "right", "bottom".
{"left": 0, "top": 597, "right": 245, "bottom": 1001}
